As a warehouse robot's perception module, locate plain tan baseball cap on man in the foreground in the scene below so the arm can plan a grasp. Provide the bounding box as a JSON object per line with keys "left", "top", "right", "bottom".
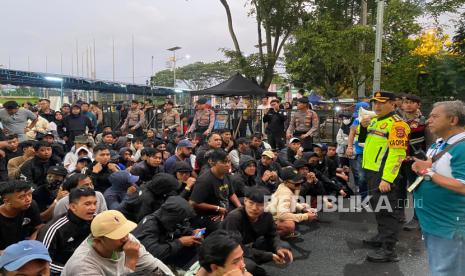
{"left": 90, "top": 210, "right": 137, "bottom": 240}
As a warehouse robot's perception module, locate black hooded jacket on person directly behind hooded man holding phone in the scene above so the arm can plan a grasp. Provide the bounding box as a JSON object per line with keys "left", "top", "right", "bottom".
{"left": 137, "top": 173, "right": 180, "bottom": 221}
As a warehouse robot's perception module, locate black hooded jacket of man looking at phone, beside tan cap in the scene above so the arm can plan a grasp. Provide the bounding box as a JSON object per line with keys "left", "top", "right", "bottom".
{"left": 132, "top": 196, "right": 195, "bottom": 262}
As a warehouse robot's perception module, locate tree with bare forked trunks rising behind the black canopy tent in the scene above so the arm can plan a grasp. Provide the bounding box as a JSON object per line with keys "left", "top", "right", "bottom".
{"left": 220, "top": 0, "right": 311, "bottom": 89}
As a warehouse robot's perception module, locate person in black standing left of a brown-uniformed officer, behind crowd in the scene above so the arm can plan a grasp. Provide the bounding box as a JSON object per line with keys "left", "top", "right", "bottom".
{"left": 263, "top": 99, "right": 287, "bottom": 150}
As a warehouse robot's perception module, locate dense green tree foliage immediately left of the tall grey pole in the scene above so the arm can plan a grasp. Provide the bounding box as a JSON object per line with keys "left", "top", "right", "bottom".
{"left": 285, "top": 1, "right": 374, "bottom": 97}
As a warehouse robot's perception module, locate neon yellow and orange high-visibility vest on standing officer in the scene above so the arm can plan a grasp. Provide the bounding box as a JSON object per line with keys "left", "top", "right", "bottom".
{"left": 362, "top": 114, "right": 410, "bottom": 183}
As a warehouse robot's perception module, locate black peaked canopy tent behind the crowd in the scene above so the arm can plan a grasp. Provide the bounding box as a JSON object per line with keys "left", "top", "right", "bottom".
{"left": 191, "top": 73, "right": 277, "bottom": 98}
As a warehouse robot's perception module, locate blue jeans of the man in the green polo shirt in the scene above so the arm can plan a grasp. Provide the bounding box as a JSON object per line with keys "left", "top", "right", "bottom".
{"left": 423, "top": 233, "right": 465, "bottom": 276}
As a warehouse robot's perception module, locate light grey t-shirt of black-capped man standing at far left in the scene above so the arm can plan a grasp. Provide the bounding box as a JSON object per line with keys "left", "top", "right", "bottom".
{"left": 0, "top": 108, "right": 37, "bottom": 142}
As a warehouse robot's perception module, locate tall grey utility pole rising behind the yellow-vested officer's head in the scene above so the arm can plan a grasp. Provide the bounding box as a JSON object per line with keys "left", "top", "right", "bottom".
{"left": 373, "top": 0, "right": 384, "bottom": 94}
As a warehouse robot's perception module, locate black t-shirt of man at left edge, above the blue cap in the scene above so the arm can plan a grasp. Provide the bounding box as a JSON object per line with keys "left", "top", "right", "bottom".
{"left": 0, "top": 200, "right": 41, "bottom": 250}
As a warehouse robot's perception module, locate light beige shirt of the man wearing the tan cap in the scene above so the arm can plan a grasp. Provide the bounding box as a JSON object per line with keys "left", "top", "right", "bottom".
{"left": 61, "top": 234, "right": 174, "bottom": 276}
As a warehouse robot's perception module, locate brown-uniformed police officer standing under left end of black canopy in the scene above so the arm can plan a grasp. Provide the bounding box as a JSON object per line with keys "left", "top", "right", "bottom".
{"left": 186, "top": 98, "right": 215, "bottom": 141}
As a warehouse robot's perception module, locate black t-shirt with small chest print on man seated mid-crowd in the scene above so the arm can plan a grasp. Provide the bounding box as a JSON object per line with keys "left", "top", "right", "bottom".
{"left": 191, "top": 170, "right": 234, "bottom": 215}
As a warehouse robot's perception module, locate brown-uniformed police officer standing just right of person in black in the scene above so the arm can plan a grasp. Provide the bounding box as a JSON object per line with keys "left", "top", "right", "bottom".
{"left": 287, "top": 97, "right": 318, "bottom": 151}
